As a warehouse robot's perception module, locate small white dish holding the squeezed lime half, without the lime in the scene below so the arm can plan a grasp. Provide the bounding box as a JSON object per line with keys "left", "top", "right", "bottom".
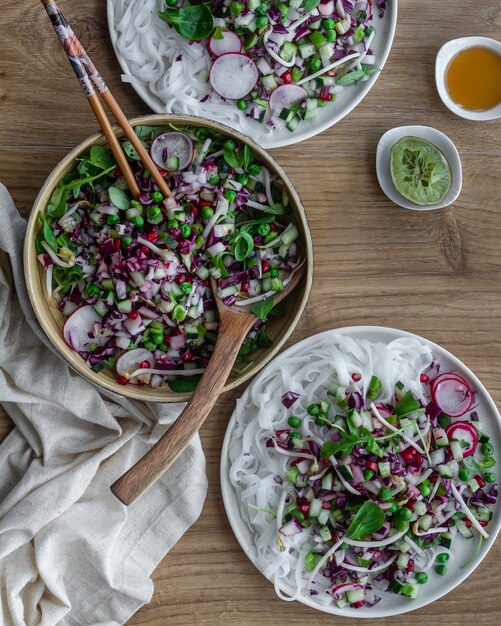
{"left": 376, "top": 126, "right": 463, "bottom": 211}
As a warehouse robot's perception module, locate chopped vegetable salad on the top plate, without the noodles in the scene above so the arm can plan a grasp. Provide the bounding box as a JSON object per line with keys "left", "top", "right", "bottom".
{"left": 160, "top": 0, "right": 386, "bottom": 131}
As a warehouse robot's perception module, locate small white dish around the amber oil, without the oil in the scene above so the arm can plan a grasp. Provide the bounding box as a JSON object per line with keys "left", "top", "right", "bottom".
{"left": 435, "top": 37, "right": 501, "bottom": 122}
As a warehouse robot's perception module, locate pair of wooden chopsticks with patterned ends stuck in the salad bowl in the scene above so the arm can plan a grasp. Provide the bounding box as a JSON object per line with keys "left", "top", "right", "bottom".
{"left": 41, "top": 0, "right": 172, "bottom": 199}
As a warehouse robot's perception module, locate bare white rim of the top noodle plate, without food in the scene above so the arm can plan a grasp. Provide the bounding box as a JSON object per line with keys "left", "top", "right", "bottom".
{"left": 107, "top": 0, "right": 397, "bottom": 149}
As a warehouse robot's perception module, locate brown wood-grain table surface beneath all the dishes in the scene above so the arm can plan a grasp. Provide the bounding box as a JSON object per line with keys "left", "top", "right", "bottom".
{"left": 0, "top": 0, "right": 501, "bottom": 626}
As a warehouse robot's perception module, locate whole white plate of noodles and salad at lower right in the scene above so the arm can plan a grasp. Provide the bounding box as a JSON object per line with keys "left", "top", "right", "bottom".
{"left": 221, "top": 326, "right": 501, "bottom": 617}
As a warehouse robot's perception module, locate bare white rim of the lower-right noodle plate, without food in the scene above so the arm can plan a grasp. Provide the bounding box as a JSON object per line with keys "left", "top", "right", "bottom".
{"left": 221, "top": 326, "right": 501, "bottom": 617}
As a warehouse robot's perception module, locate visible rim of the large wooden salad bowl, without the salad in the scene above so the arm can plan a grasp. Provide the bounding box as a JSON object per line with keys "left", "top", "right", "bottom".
{"left": 24, "top": 115, "right": 313, "bottom": 402}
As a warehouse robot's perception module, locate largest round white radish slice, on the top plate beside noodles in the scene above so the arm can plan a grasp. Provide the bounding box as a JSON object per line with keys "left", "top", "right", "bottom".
{"left": 209, "top": 52, "right": 259, "bottom": 100}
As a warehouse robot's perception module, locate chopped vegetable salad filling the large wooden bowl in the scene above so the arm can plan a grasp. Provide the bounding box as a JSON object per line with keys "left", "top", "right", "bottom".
{"left": 36, "top": 125, "right": 300, "bottom": 392}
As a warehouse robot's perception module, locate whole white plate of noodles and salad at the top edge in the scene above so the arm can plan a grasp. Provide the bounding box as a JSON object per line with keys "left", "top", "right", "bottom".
{"left": 107, "top": 0, "right": 397, "bottom": 149}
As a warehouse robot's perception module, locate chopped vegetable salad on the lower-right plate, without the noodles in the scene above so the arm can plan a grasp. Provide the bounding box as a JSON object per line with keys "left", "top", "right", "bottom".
{"left": 266, "top": 364, "right": 498, "bottom": 608}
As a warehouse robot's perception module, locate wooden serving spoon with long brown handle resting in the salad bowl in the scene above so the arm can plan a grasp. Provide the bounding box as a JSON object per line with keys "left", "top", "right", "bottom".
{"left": 111, "top": 254, "right": 305, "bottom": 506}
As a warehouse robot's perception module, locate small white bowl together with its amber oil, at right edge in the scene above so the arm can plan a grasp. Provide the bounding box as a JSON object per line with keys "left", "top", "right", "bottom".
{"left": 435, "top": 37, "right": 501, "bottom": 122}
